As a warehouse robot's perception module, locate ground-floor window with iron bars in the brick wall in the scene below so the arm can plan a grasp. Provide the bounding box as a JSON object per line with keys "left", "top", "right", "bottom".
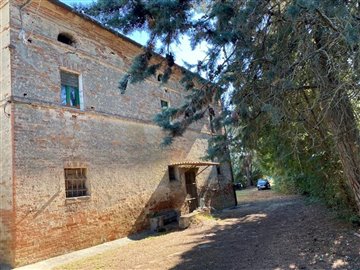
{"left": 64, "top": 168, "right": 88, "bottom": 198}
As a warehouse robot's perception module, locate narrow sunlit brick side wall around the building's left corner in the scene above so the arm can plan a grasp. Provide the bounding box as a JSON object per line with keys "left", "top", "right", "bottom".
{"left": 0, "top": 1, "right": 14, "bottom": 267}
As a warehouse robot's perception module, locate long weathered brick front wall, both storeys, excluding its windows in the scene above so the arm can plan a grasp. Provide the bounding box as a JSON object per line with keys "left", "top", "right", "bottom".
{"left": 5, "top": 0, "right": 233, "bottom": 265}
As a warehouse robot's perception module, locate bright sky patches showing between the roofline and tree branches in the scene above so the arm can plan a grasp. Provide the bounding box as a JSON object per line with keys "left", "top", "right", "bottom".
{"left": 61, "top": 0, "right": 206, "bottom": 65}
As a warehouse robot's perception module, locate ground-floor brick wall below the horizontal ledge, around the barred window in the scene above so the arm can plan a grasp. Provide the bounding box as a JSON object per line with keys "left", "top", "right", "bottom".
{"left": 15, "top": 105, "right": 222, "bottom": 264}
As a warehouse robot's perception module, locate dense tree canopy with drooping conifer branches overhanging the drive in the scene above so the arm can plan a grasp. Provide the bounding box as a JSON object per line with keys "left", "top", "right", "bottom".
{"left": 86, "top": 0, "right": 360, "bottom": 217}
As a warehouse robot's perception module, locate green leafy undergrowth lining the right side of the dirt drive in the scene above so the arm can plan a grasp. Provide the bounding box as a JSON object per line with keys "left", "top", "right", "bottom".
{"left": 232, "top": 99, "right": 360, "bottom": 221}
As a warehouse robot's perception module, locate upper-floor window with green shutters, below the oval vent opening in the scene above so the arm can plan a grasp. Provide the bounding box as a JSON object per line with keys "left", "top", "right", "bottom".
{"left": 60, "top": 71, "right": 80, "bottom": 109}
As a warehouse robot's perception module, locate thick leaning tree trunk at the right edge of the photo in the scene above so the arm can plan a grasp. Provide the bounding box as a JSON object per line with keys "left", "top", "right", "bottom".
{"left": 314, "top": 27, "right": 360, "bottom": 215}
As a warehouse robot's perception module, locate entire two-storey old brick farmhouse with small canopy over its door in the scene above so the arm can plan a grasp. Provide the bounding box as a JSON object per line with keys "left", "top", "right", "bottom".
{"left": 0, "top": 0, "right": 235, "bottom": 267}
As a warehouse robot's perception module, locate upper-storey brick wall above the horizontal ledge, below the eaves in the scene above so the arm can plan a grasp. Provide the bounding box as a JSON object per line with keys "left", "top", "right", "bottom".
{"left": 11, "top": 1, "right": 207, "bottom": 125}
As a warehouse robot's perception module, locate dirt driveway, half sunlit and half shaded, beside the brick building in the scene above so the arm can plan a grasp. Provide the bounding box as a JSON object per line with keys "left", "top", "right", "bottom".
{"left": 58, "top": 189, "right": 360, "bottom": 270}
